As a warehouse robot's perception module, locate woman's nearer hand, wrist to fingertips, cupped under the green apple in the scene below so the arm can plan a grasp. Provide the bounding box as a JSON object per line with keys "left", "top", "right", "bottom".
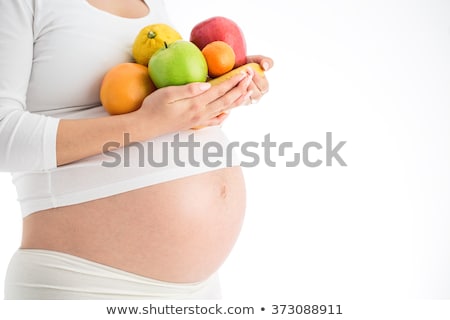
{"left": 135, "top": 72, "right": 254, "bottom": 139}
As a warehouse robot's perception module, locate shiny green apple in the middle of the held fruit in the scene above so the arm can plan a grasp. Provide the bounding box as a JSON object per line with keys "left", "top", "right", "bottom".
{"left": 148, "top": 40, "right": 208, "bottom": 88}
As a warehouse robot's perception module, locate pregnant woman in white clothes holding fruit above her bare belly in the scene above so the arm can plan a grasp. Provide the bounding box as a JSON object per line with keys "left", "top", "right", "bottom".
{"left": 0, "top": 0, "right": 272, "bottom": 299}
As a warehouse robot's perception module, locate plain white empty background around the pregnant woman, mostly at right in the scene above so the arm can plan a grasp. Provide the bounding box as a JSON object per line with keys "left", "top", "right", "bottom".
{"left": 0, "top": 0, "right": 450, "bottom": 318}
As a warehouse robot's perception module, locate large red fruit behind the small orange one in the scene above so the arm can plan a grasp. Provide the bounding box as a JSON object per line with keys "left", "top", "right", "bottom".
{"left": 190, "top": 17, "right": 247, "bottom": 68}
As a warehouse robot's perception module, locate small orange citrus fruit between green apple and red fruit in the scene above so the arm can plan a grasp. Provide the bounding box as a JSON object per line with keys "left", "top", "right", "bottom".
{"left": 202, "top": 41, "right": 236, "bottom": 78}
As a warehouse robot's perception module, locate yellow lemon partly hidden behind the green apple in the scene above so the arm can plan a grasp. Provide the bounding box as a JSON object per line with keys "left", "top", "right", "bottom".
{"left": 132, "top": 23, "right": 182, "bottom": 66}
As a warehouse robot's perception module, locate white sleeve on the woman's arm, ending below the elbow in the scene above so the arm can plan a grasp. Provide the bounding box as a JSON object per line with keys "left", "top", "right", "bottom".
{"left": 0, "top": 0, "right": 59, "bottom": 172}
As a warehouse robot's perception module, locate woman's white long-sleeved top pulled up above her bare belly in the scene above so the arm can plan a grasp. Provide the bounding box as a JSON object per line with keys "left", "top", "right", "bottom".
{"left": 0, "top": 0, "right": 236, "bottom": 216}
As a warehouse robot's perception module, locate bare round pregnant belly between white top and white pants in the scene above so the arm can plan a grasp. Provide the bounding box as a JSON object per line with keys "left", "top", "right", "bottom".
{"left": 22, "top": 167, "right": 245, "bottom": 282}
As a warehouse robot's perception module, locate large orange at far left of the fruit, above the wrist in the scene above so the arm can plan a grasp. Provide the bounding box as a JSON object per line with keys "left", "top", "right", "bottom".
{"left": 100, "top": 62, "right": 156, "bottom": 115}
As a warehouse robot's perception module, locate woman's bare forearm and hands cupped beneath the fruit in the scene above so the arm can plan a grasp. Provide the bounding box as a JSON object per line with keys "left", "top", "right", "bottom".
{"left": 56, "top": 56, "right": 273, "bottom": 166}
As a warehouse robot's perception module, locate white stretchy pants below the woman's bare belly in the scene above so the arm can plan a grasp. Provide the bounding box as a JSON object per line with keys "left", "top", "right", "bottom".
{"left": 5, "top": 249, "right": 220, "bottom": 300}
